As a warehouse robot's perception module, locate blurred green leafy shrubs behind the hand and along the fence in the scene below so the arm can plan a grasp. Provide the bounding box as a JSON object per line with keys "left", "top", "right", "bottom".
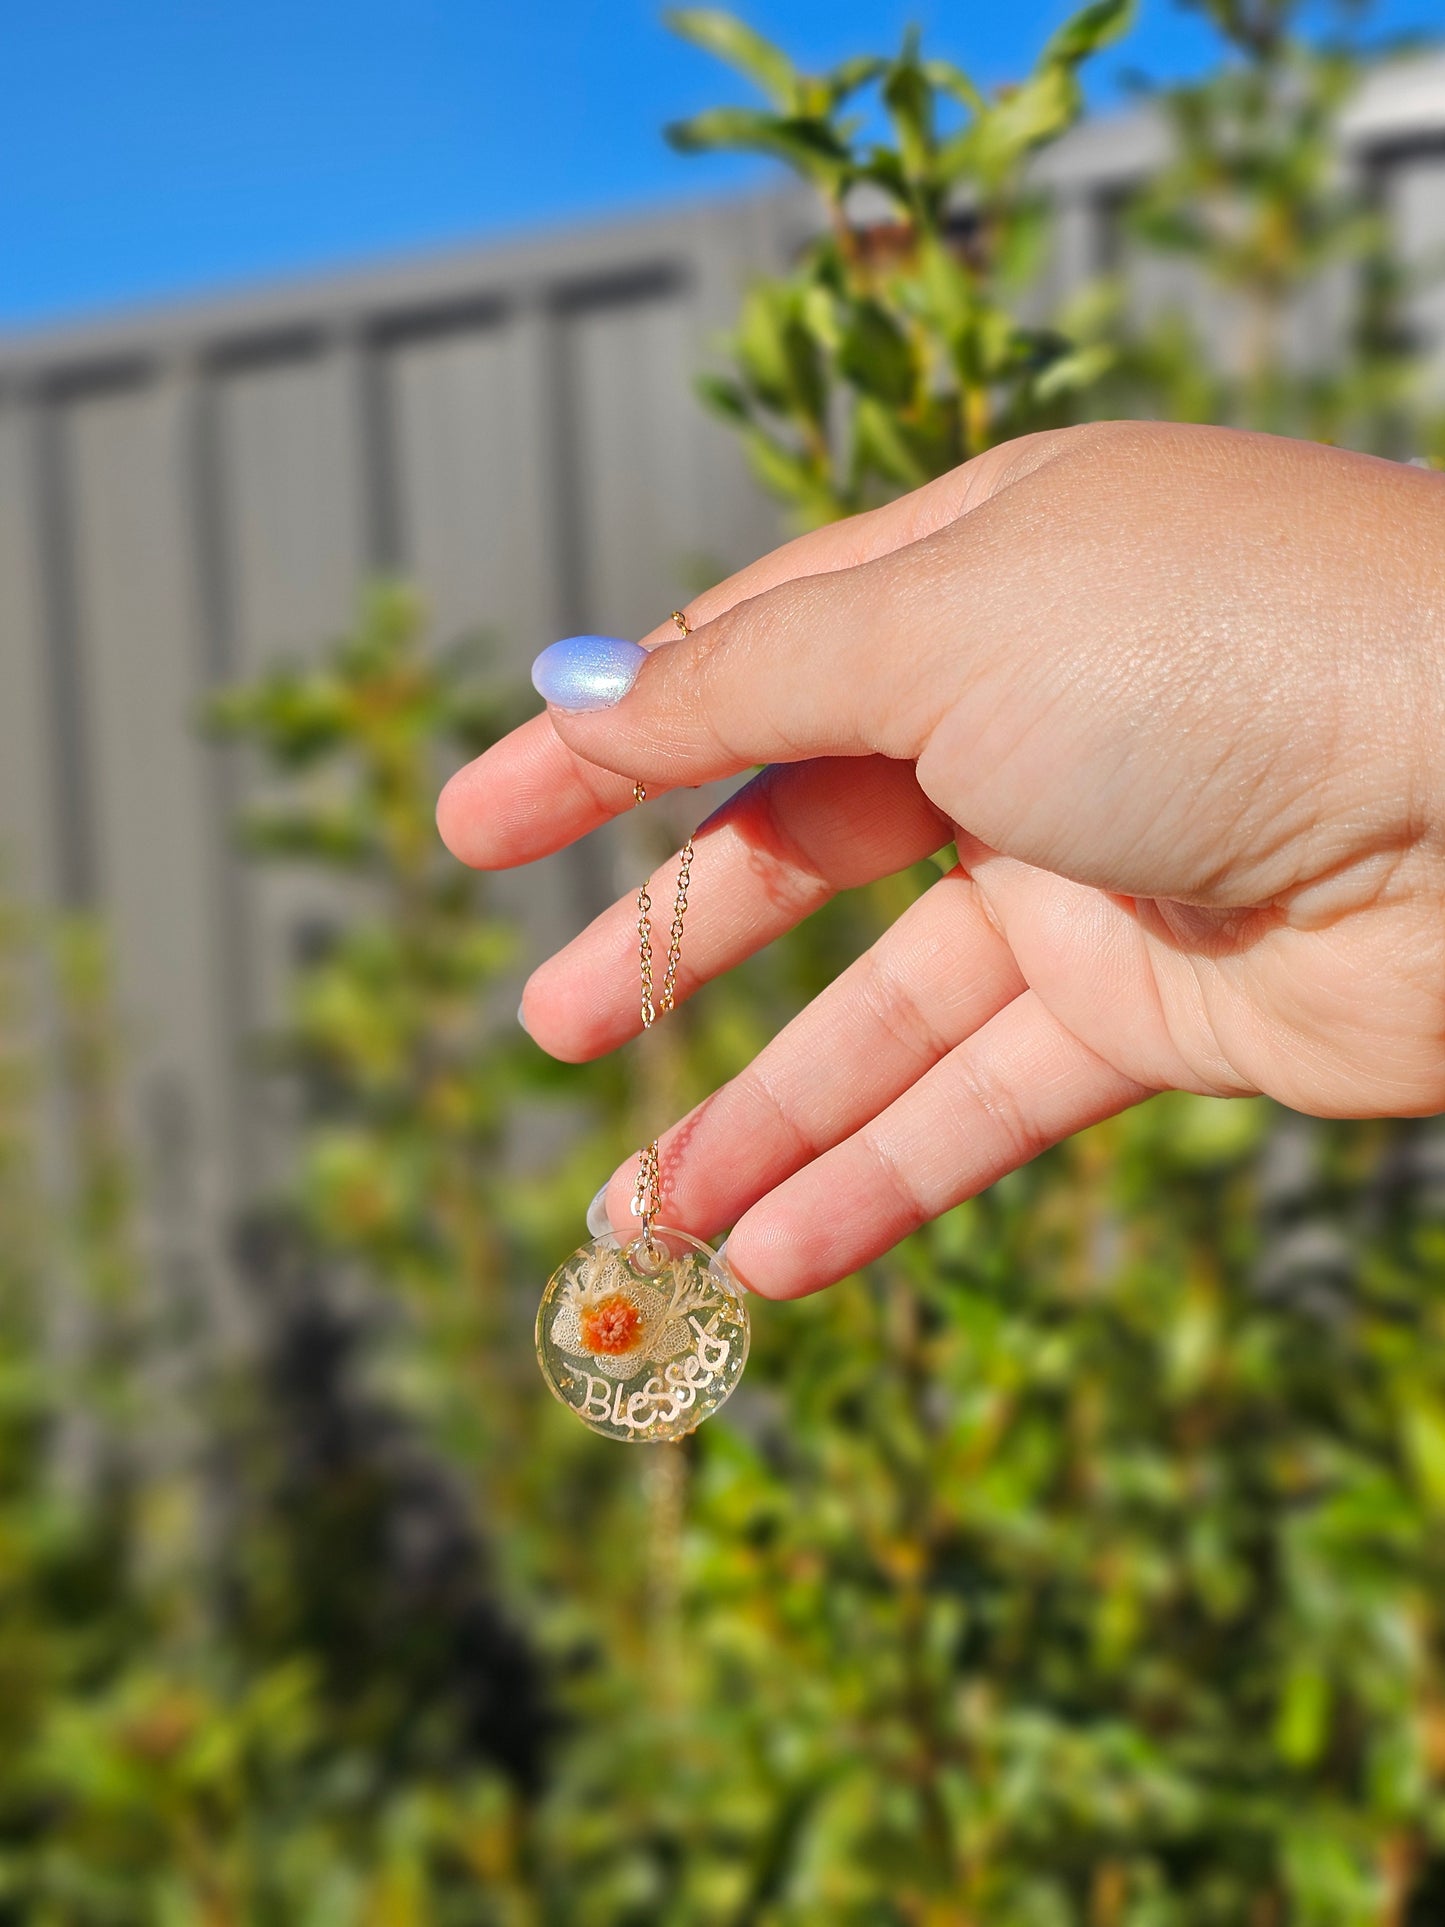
{"left": 0, "top": 0, "right": 1445, "bottom": 1927}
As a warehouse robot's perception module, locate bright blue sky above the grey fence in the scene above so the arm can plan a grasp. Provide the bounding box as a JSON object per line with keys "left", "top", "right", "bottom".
{"left": 0, "top": 0, "right": 1445, "bottom": 328}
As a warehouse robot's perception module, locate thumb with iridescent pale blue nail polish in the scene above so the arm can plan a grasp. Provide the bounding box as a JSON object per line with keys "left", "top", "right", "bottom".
{"left": 532, "top": 428, "right": 1092, "bottom": 786}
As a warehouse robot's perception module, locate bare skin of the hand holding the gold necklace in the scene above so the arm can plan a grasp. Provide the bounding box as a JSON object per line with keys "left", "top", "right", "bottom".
{"left": 437, "top": 422, "right": 1445, "bottom": 1299}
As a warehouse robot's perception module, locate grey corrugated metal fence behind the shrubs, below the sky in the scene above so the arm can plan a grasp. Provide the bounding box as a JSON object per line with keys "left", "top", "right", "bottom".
{"left": 0, "top": 60, "right": 1445, "bottom": 1310}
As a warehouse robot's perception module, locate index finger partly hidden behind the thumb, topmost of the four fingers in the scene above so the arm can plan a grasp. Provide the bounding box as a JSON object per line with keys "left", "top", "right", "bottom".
{"left": 437, "top": 436, "right": 1058, "bottom": 869}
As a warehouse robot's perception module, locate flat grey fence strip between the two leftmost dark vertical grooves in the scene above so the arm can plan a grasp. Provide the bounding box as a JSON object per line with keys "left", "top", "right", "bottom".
{"left": 65, "top": 371, "right": 237, "bottom": 1341}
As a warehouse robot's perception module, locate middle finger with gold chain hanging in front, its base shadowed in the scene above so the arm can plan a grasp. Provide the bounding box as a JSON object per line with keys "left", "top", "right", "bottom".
{"left": 522, "top": 757, "right": 954, "bottom": 1064}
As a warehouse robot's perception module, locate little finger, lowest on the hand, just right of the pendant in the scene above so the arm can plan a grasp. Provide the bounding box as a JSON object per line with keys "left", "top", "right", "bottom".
{"left": 728, "top": 990, "right": 1150, "bottom": 1299}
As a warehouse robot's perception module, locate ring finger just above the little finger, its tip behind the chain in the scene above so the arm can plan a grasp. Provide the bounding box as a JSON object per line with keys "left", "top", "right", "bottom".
{"left": 607, "top": 869, "right": 1023, "bottom": 1233}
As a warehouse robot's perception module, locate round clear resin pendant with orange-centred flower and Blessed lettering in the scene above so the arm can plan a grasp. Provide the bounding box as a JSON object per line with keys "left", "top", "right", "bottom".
{"left": 538, "top": 1224, "right": 748, "bottom": 1445}
